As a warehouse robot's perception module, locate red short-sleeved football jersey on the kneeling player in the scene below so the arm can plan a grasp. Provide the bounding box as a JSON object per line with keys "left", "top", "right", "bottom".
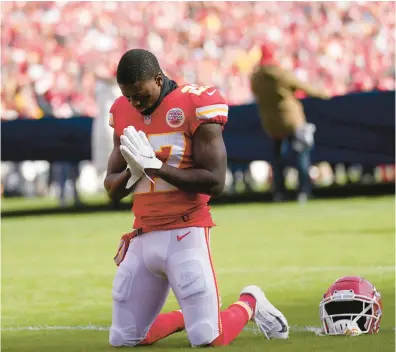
{"left": 110, "top": 85, "right": 228, "bottom": 232}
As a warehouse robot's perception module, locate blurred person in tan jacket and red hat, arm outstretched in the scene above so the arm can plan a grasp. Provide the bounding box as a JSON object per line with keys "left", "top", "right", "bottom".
{"left": 251, "top": 44, "right": 329, "bottom": 201}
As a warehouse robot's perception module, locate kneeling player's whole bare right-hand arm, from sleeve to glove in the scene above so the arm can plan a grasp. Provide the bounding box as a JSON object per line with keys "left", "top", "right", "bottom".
{"left": 146, "top": 123, "right": 227, "bottom": 196}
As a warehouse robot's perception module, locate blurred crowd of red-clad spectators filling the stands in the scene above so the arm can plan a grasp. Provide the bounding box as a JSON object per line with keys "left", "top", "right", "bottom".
{"left": 1, "top": 1, "right": 395, "bottom": 119}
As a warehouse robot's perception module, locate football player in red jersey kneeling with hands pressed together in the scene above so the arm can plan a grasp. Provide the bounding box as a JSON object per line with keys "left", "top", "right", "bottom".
{"left": 104, "top": 49, "right": 289, "bottom": 346}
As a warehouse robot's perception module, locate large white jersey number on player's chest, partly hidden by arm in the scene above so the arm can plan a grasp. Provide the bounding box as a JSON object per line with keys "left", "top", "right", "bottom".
{"left": 134, "top": 132, "right": 186, "bottom": 194}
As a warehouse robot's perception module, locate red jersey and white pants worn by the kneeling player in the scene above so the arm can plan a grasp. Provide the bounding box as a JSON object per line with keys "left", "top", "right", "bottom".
{"left": 110, "top": 85, "right": 228, "bottom": 346}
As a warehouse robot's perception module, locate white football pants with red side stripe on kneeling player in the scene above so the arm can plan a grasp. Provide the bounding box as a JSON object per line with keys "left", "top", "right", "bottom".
{"left": 110, "top": 227, "right": 220, "bottom": 346}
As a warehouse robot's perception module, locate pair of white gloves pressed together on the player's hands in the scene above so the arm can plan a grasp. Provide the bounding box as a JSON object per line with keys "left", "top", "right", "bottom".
{"left": 120, "top": 126, "right": 162, "bottom": 183}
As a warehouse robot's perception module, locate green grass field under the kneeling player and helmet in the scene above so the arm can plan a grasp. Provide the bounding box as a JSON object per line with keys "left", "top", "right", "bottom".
{"left": 2, "top": 197, "right": 395, "bottom": 352}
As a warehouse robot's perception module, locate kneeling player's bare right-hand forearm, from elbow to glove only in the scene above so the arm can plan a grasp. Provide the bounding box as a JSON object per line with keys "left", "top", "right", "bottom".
{"left": 155, "top": 164, "right": 225, "bottom": 196}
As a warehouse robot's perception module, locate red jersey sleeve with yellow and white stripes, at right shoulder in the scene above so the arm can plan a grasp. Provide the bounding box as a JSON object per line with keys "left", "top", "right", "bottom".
{"left": 190, "top": 87, "right": 228, "bottom": 135}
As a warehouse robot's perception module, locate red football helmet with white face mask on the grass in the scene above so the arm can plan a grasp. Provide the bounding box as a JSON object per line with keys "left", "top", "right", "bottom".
{"left": 319, "top": 276, "right": 382, "bottom": 335}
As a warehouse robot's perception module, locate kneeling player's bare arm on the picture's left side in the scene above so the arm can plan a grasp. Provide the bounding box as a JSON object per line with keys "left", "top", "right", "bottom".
{"left": 104, "top": 132, "right": 133, "bottom": 200}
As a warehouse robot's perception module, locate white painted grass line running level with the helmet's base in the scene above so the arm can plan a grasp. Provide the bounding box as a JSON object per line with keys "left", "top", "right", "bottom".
{"left": 1, "top": 325, "right": 321, "bottom": 334}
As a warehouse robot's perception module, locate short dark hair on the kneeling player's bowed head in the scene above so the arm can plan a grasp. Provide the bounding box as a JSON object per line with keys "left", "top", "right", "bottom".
{"left": 117, "top": 49, "right": 162, "bottom": 84}
